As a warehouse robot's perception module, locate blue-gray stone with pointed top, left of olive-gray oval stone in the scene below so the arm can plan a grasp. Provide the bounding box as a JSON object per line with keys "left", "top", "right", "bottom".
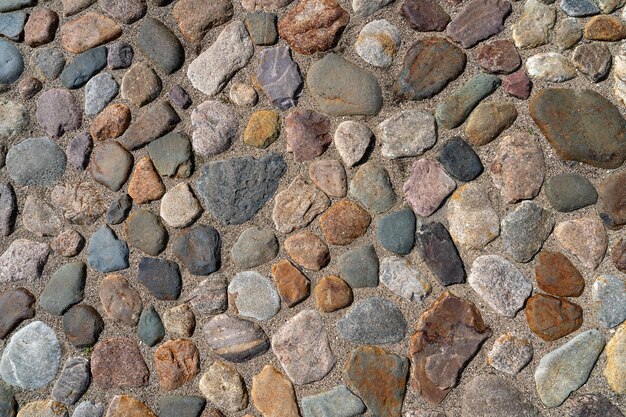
{"left": 87, "top": 224, "right": 128, "bottom": 272}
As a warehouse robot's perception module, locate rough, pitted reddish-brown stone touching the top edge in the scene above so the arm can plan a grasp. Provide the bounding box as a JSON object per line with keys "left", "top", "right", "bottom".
{"left": 278, "top": 0, "right": 350, "bottom": 55}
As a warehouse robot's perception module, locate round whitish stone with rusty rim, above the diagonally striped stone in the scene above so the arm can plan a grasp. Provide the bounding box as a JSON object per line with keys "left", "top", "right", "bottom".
{"left": 228, "top": 271, "right": 280, "bottom": 321}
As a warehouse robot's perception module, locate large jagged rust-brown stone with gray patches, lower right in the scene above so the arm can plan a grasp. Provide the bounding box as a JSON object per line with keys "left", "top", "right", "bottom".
{"left": 409, "top": 291, "right": 491, "bottom": 404}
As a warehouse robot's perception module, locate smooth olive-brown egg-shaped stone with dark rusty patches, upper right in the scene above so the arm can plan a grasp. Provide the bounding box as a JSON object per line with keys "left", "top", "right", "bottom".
{"left": 395, "top": 37, "right": 467, "bottom": 100}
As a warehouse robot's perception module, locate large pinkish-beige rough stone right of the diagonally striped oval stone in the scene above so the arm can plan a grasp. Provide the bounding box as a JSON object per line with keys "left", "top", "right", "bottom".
{"left": 272, "top": 310, "right": 336, "bottom": 385}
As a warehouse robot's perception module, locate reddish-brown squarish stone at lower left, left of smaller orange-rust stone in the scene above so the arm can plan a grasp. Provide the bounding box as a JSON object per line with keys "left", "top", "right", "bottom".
{"left": 91, "top": 338, "right": 150, "bottom": 388}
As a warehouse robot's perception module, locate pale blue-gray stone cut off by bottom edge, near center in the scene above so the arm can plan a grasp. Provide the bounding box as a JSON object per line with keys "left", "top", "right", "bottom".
{"left": 300, "top": 385, "right": 365, "bottom": 417}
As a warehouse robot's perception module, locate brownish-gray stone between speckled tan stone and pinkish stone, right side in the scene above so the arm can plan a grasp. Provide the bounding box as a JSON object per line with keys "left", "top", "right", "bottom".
{"left": 500, "top": 201, "right": 554, "bottom": 262}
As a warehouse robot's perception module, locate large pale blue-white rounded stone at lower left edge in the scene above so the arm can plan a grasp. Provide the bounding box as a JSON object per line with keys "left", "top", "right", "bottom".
{"left": 0, "top": 321, "right": 61, "bottom": 389}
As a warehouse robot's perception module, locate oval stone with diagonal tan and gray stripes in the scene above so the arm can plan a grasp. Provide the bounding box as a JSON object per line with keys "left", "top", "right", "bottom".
{"left": 203, "top": 314, "right": 270, "bottom": 360}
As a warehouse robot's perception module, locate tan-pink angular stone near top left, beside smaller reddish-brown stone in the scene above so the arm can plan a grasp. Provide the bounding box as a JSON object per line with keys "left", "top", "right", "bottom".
{"left": 61, "top": 12, "right": 122, "bottom": 54}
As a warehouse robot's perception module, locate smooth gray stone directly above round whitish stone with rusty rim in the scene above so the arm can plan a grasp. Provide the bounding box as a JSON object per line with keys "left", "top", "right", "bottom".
{"left": 230, "top": 226, "right": 278, "bottom": 269}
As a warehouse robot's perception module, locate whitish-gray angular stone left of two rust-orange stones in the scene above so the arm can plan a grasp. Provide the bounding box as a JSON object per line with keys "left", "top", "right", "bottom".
{"left": 467, "top": 255, "right": 533, "bottom": 318}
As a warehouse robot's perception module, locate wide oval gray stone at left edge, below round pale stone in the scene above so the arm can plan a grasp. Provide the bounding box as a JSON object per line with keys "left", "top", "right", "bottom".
{"left": 6, "top": 137, "right": 67, "bottom": 187}
